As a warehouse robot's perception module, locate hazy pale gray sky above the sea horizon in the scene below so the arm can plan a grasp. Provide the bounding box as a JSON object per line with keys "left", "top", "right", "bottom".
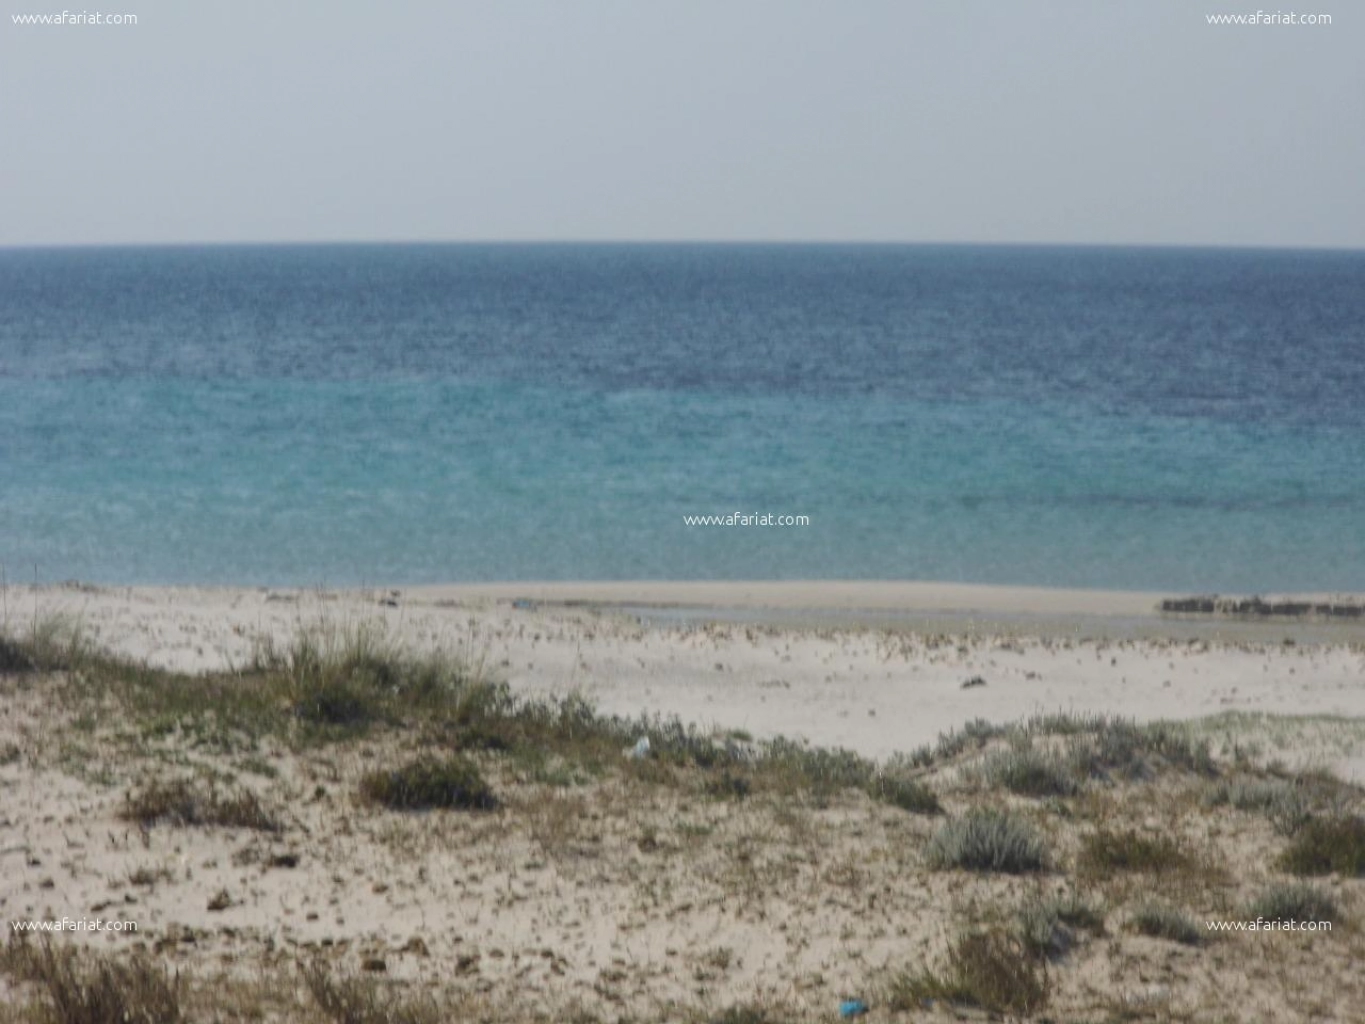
{"left": 0, "top": 0, "right": 1365, "bottom": 247}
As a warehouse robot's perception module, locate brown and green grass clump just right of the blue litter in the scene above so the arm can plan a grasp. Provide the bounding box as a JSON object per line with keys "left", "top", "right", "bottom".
{"left": 887, "top": 930, "right": 1048, "bottom": 1014}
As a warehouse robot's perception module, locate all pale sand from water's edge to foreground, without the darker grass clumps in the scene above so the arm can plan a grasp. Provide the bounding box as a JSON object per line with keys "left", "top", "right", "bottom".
{"left": 0, "top": 583, "right": 1365, "bottom": 1024}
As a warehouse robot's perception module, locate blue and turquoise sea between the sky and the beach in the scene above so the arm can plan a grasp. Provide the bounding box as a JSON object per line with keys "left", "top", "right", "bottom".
{"left": 0, "top": 244, "right": 1365, "bottom": 593}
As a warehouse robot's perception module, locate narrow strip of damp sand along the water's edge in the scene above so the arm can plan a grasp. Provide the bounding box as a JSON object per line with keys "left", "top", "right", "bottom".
{"left": 18, "top": 580, "right": 1365, "bottom": 644}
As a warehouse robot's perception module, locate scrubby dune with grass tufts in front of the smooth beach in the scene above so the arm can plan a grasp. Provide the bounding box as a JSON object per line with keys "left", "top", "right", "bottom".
{"left": 0, "top": 627, "right": 1365, "bottom": 1024}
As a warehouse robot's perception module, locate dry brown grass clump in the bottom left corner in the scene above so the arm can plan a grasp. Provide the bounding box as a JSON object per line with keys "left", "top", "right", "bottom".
{"left": 0, "top": 939, "right": 184, "bottom": 1024}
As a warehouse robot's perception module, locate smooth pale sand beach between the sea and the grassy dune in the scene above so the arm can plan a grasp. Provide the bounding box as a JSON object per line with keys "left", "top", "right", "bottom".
{"left": 18, "top": 582, "right": 1365, "bottom": 778}
